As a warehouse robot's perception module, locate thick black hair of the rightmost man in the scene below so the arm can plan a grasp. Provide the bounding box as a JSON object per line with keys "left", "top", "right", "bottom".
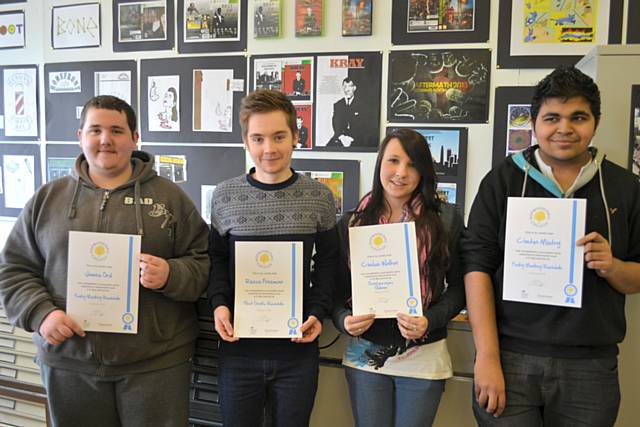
{"left": 531, "top": 66, "right": 601, "bottom": 126}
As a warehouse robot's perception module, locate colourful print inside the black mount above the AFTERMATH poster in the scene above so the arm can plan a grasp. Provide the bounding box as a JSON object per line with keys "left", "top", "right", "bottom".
{"left": 407, "top": 0, "right": 475, "bottom": 33}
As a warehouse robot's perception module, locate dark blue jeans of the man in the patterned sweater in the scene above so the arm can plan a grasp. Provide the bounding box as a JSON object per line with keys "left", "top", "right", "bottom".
{"left": 218, "top": 355, "right": 319, "bottom": 427}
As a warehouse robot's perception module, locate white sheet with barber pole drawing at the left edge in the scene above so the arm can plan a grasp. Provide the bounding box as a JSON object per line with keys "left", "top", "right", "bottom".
{"left": 0, "top": 65, "right": 40, "bottom": 141}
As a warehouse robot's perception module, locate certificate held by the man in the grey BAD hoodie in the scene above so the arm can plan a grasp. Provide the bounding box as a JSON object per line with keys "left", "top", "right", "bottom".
{"left": 67, "top": 231, "right": 141, "bottom": 334}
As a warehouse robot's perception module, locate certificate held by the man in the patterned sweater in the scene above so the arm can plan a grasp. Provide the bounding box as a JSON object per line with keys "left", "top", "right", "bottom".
{"left": 233, "top": 242, "right": 304, "bottom": 338}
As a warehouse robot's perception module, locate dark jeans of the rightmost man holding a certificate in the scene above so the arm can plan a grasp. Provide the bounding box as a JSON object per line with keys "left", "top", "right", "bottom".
{"left": 473, "top": 351, "right": 620, "bottom": 427}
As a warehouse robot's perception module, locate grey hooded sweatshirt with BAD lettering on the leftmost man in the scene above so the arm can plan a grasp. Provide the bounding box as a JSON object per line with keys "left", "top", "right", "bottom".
{"left": 0, "top": 151, "right": 209, "bottom": 375}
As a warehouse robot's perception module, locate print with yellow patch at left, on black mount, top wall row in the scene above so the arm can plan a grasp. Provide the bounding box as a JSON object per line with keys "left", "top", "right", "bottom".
{"left": 183, "top": 0, "right": 240, "bottom": 43}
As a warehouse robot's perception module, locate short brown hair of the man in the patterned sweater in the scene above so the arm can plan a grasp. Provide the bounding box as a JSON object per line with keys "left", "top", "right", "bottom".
{"left": 240, "top": 89, "right": 298, "bottom": 136}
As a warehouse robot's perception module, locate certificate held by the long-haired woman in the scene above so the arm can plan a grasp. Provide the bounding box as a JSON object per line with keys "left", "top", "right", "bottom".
{"left": 349, "top": 222, "right": 422, "bottom": 318}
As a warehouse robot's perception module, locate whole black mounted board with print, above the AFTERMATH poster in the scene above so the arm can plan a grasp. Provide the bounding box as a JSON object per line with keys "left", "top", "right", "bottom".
{"left": 391, "top": 0, "right": 490, "bottom": 45}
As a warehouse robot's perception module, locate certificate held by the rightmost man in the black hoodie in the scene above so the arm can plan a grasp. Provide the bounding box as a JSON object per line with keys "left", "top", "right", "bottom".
{"left": 502, "top": 197, "right": 587, "bottom": 308}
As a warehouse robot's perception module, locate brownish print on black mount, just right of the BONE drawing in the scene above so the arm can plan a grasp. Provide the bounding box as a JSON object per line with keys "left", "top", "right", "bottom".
{"left": 118, "top": 0, "right": 167, "bottom": 43}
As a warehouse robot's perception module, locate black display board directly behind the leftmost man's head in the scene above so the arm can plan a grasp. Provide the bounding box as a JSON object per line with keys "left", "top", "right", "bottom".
{"left": 44, "top": 61, "right": 138, "bottom": 141}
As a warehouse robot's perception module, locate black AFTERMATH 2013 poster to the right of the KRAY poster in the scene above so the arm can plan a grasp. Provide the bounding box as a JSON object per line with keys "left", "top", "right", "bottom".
{"left": 387, "top": 49, "right": 491, "bottom": 123}
